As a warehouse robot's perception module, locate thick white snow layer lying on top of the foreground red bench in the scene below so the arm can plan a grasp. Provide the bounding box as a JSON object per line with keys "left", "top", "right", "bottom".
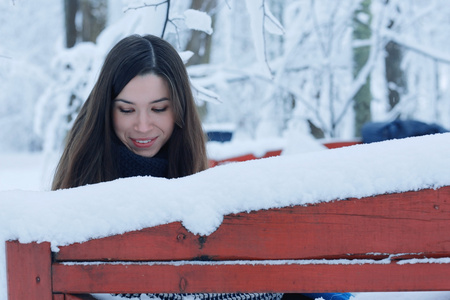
{"left": 0, "top": 133, "right": 450, "bottom": 299}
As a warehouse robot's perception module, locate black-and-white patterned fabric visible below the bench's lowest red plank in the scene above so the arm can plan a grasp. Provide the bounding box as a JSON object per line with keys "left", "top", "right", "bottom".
{"left": 120, "top": 293, "right": 283, "bottom": 300}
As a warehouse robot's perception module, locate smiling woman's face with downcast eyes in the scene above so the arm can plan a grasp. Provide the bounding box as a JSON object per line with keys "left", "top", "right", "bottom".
{"left": 112, "top": 74, "right": 175, "bottom": 157}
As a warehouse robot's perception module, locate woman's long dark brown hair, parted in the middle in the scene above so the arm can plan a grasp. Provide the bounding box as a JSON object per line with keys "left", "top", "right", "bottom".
{"left": 52, "top": 35, "right": 208, "bottom": 190}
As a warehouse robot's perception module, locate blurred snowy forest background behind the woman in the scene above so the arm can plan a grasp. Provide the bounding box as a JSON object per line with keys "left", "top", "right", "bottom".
{"left": 0, "top": 0, "right": 450, "bottom": 152}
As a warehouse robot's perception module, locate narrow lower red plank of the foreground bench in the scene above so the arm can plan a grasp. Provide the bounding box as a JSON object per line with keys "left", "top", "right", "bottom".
{"left": 53, "top": 263, "right": 450, "bottom": 293}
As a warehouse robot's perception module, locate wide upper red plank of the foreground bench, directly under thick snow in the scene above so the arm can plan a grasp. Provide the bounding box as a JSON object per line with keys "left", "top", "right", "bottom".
{"left": 56, "top": 187, "right": 450, "bottom": 261}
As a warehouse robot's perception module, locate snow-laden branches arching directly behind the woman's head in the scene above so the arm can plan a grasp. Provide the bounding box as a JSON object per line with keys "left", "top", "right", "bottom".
{"left": 34, "top": 1, "right": 216, "bottom": 152}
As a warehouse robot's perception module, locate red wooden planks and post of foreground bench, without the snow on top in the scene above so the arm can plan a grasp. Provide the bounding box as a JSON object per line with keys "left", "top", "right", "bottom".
{"left": 6, "top": 186, "right": 450, "bottom": 300}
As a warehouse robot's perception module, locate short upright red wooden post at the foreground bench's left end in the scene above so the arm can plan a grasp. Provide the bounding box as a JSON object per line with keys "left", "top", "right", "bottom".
{"left": 6, "top": 241, "right": 52, "bottom": 300}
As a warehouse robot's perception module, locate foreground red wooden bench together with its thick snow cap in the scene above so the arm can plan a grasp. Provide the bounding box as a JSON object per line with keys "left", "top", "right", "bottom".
{"left": 0, "top": 134, "right": 450, "bottom": 299}
